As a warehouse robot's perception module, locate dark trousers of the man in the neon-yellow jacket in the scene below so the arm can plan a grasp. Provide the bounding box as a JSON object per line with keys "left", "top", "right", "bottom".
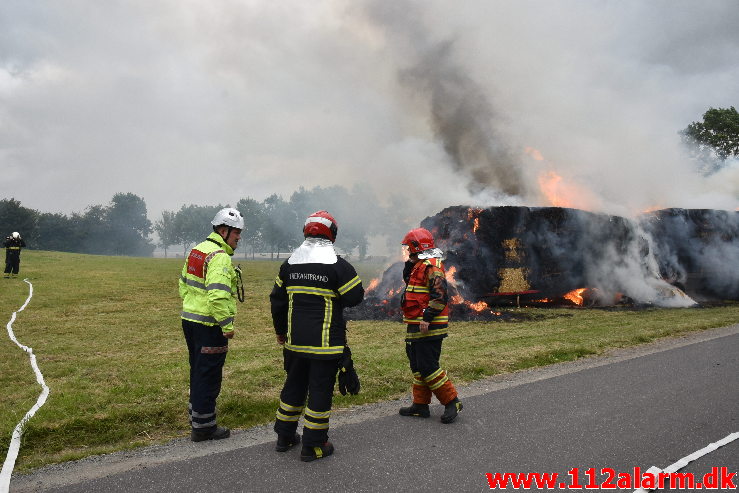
{"left": 182, "top": 320, "right": 228, "bottom": 431}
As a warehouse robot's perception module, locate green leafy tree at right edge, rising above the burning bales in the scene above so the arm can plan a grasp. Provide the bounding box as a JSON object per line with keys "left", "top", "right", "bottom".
{"left": 681, "top": 106, "right": 739, "bottom": 171}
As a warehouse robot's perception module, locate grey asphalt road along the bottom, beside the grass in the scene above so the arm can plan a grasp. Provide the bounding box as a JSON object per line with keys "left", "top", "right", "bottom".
{"left": 10, "top": 325, "right": 739, "bottom": 492}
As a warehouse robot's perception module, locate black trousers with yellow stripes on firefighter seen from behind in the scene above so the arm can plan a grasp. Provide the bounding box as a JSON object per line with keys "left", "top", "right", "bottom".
{"left": 274, "top": 350, "right": 339, "bottom": 447}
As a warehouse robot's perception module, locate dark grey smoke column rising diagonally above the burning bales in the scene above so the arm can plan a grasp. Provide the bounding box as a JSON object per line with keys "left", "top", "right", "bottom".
{"left": 360, "top": 1, "right": 527, "bottom": 196}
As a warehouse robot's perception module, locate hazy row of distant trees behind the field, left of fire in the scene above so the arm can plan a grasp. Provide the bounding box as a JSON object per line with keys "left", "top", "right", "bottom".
{"left": 0, "top": 185, "right": 408, "bottom": 259}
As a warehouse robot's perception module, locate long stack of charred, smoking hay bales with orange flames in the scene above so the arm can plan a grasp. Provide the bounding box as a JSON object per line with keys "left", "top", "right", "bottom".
{"left": 349, "top": 207, "right": 739, "bottom": 320}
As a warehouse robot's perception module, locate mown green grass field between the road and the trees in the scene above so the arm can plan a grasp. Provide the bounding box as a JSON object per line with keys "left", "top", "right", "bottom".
{"left": 0, "top": 250, "right": 739, "bottom": 471}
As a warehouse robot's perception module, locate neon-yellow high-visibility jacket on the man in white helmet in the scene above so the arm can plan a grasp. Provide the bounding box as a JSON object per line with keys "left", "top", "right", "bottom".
{"left": 179, "top": 232, "right": 236, "bottom": 332}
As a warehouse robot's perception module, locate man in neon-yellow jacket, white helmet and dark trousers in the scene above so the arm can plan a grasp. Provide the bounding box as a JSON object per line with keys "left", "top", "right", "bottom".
{"left": 179, "top": 207, "right": 244, "bottom": 442}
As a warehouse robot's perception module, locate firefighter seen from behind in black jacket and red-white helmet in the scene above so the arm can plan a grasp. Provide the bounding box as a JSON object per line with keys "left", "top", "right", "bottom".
{"left": 270, "top": 211, "right": 364, "bottom": 462}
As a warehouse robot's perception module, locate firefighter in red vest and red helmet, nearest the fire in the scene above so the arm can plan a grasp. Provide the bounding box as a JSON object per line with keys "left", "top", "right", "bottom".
{"left": 400, "top": 228, "right": 462, "bottom": 423}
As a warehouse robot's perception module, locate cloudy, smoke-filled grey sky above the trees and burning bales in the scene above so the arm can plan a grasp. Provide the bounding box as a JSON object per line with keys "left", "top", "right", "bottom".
{"left": 0, "top": 0, "right": 739, "bottom": 225}
